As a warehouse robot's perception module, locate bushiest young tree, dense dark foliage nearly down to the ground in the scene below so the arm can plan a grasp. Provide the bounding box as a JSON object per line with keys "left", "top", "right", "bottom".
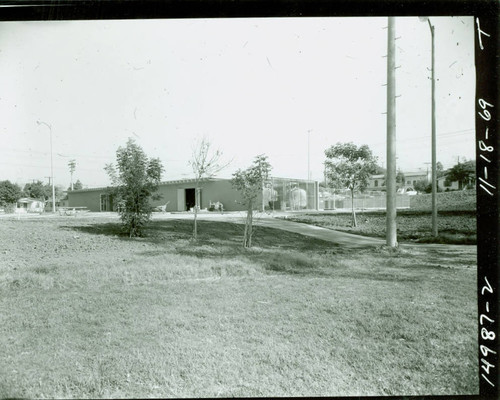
{"left": 104, "top": 139, "right": 163, "bottom": 237}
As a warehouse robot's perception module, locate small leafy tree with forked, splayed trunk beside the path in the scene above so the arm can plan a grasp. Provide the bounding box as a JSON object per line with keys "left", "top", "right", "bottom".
{"left": 231, "top": 154, "right": 271, "bottom": 247}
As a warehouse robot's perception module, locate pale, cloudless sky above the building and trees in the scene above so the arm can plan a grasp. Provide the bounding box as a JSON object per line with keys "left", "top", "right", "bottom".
{"left": 0, "top": 17, "right": 475, "bottom": 187}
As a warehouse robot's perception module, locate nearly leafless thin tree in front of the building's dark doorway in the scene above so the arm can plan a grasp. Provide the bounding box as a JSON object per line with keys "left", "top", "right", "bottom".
{"left": 189, "top": 137, "right": 229, "bottom": 240}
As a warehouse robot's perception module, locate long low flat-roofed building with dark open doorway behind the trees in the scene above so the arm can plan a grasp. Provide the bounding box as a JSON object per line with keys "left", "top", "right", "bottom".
{"left": 68, "top": 178, "right": 319, "bottom": 212}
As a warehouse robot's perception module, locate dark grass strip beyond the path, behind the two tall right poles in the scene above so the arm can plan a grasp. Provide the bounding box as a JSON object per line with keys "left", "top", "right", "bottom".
{"left": 287, "top": 210, "right": 477, "bottom": 244}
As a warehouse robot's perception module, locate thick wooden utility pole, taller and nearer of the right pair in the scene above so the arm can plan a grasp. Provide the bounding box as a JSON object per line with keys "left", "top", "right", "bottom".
{"left": 386, "top": 17, "right": 398, "bottom": 247}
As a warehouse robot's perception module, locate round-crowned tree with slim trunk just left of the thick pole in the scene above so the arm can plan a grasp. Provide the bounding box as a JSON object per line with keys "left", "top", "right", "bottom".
{"left": 325, "top": 143, "right": 377, "bottom": 227}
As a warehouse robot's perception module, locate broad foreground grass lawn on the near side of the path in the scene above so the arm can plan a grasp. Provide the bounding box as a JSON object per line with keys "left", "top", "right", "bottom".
{"left": 0, "top": 218, "right": 478, "bottom": 398}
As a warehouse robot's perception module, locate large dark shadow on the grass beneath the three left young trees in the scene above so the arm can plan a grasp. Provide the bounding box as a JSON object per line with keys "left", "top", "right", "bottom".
{"left": 63, "top": 219, "right": 348, "bottom": 275}
